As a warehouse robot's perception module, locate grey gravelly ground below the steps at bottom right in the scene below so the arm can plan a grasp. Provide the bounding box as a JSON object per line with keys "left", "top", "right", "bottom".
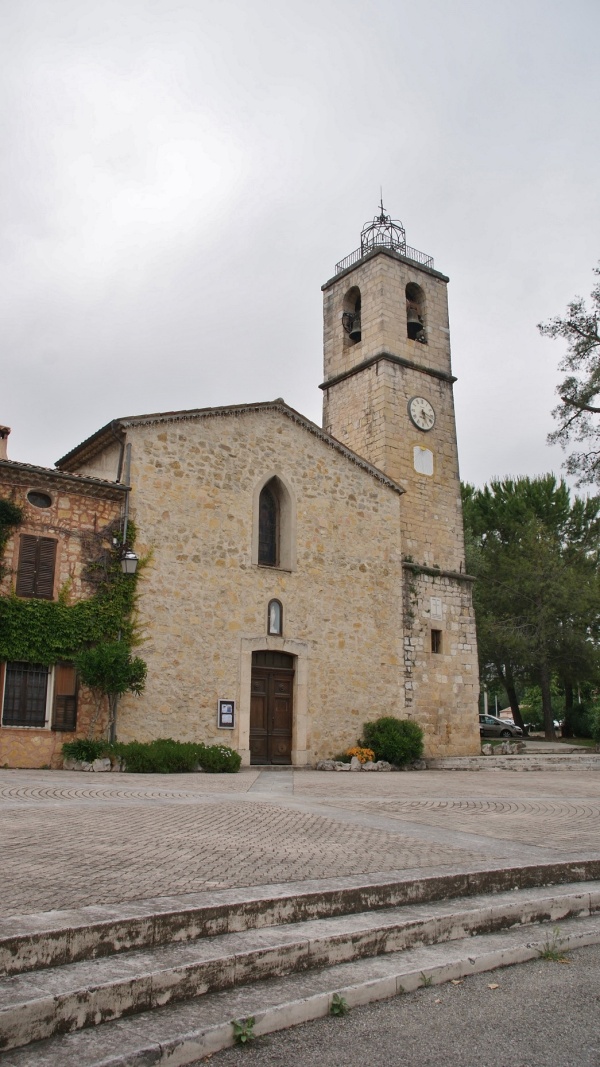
{"left": 195, "top": 945, "right": 600, "bottom": 1067}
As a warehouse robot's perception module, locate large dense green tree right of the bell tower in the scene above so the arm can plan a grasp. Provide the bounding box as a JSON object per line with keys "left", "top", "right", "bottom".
{"left": 462, "top": 475, "right": 600, "bottom": 738}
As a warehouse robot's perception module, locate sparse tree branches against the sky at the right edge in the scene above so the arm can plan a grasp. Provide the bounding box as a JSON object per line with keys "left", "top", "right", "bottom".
{"left": 538, "top": 267, "right": 600, "bottom": 484}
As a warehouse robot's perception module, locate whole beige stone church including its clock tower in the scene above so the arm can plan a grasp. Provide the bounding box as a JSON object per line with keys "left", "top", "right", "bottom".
{"left": 0, "top": 205, "right": 479, "bottom": 766}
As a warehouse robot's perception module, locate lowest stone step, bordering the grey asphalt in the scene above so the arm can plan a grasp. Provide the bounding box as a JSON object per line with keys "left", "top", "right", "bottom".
{"left": 2, "top": 915, "right": 600, "bottom": 1067}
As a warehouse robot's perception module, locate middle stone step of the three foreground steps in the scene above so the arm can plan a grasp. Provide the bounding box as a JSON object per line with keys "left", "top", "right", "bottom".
{"left": 0, "top": 881, "right": 600, "bottom": 1050}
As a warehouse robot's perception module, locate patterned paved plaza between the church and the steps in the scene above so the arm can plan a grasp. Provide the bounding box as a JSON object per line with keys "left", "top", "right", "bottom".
{"left": 0, "top": 762, "right": 600, "bottom": 917}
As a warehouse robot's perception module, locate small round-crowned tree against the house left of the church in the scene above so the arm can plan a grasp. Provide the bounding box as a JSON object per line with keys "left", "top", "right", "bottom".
{"left": 75, "top": 641, "right": 147, "bottom": 740}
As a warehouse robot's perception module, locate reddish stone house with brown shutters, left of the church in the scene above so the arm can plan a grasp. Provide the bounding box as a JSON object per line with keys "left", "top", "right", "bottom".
{"left": 0, "top": 427, "right": 127, "bottom": 767}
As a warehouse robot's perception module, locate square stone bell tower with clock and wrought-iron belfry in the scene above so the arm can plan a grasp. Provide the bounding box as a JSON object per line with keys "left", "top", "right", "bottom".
{"left": 320, "top": 204, "right": 479, "bottom": 755}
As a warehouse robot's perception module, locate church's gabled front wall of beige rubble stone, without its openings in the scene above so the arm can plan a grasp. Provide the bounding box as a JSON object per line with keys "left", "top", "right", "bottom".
{"left": 72, "top": 410, "right": 404, "bottom": 763}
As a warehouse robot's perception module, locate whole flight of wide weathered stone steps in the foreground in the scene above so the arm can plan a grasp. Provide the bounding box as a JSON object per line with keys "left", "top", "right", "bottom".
{"left": 0, "top": 861, "right": 600, "bottom": 1067}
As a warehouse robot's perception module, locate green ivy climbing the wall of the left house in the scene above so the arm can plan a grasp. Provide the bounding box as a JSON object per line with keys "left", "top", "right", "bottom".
{"left": 0, "top": 500, "right": 143, "bottom": 667}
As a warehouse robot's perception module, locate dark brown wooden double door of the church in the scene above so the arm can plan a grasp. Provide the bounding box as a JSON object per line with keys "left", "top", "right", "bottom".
{"left": 250, "top": 652, "right": 294, "bottom": 764}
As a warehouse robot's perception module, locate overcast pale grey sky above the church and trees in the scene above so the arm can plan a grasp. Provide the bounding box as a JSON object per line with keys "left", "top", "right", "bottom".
{"left": 0, "top": 0, "right": 600, "bottom": 484}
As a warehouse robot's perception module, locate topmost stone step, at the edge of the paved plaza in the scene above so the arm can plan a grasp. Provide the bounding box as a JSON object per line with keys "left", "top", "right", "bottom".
{"left": 0, "top": 859, "right": 600, "bottom": 975}
